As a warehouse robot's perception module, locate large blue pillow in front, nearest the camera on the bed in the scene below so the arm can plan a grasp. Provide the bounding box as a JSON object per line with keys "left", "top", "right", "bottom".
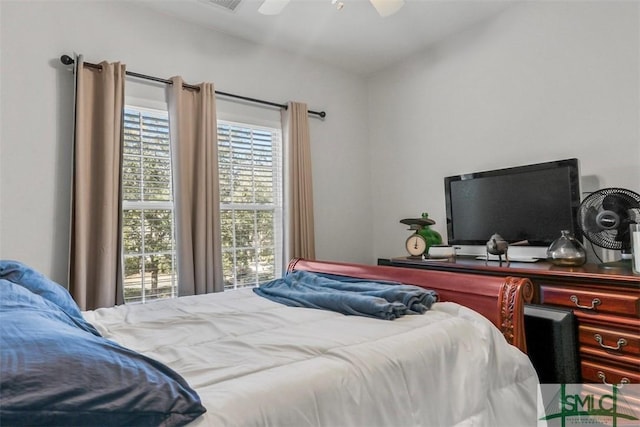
{"left": 0, "top": 279, "right": 206, "bottom": 426}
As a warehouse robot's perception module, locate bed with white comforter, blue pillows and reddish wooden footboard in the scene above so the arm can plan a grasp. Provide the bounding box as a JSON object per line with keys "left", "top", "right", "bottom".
{"left": 0, "top": 259, "right": 539, "bottom": 427}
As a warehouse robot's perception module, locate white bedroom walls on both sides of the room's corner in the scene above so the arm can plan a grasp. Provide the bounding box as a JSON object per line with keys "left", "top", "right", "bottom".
{"left": 0, "top": 0, "right": 640, "bottom": 282}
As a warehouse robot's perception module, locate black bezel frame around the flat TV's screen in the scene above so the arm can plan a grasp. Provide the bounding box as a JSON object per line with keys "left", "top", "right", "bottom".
{"left": 444, "top": 158, "right": 582, "bottom": 246}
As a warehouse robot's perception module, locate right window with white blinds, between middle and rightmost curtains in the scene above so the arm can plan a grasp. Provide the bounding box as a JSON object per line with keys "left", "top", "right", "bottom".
{"left": 218, "top": 121, "right": 283, "bottom": 289}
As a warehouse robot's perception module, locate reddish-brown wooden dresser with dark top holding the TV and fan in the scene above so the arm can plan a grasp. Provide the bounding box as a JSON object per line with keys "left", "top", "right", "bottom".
{"left": 378, "top": 257, "right": 640, "bottom": 384}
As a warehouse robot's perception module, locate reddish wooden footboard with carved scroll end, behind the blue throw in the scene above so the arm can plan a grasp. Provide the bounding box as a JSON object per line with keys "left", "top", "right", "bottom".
{"left": 287, "top": 258, "right": 533, "bottom": 353}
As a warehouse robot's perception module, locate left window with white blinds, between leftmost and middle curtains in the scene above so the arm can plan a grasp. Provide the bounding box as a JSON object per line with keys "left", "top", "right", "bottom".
{"left": 122, "top": 107, "right": 177, "bottom": 303}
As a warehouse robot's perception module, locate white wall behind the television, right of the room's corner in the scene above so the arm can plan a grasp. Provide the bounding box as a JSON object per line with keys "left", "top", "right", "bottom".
{"left": 368, "top": 1, "right": 640, "bottom": 257}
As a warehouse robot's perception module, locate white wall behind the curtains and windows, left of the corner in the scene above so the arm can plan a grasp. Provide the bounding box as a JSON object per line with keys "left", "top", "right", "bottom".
{"left": 0, "top": 0, "right": 372, "bottom": 283}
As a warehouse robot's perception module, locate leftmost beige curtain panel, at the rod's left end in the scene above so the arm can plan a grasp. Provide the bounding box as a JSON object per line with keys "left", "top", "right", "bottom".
{"left": 69, "top": 57, "right": 125, "bottom": 310}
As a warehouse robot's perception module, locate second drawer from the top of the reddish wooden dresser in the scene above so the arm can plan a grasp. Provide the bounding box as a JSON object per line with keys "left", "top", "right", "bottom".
{"left": 578, "top": 323, "right": 640, "bottom": 357}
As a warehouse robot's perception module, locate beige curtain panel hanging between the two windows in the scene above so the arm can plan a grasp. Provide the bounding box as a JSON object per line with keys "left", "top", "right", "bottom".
{"left": 168, "top": 77, "right": 224, "bottom": 296}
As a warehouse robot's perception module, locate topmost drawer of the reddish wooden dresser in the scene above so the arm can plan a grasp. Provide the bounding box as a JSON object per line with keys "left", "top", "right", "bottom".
{"left": 540, "top": 285, "right": 640, "bottom": 317}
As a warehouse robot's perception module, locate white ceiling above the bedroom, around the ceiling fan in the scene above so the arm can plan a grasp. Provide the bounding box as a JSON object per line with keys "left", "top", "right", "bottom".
{"left": 136, "top": 0, "right": 519, "bottom": 74}
